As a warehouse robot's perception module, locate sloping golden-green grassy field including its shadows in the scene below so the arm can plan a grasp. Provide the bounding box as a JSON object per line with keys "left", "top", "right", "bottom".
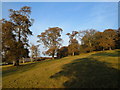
{"left": 2, "top": 50, "right": 120, "bottom": 88}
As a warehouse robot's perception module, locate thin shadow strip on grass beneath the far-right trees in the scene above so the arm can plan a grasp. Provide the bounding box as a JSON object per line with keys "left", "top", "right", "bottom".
{"left": 92, "top": 51, "right": 120, "bottom": 57}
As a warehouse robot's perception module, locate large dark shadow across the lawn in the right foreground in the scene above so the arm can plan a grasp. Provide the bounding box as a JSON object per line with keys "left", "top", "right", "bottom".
{"left": 50, "top": 58, "right": 120, "bottom": 88}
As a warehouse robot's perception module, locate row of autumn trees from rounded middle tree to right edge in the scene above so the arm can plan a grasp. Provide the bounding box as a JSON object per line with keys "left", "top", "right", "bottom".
{"left": 38, "top": 27, "right": 120, "bottom": 58}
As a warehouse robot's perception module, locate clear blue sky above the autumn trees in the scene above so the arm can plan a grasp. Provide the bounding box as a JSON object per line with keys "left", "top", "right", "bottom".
{"left": 2, "top": 2, "right": 118, "bottom": 56}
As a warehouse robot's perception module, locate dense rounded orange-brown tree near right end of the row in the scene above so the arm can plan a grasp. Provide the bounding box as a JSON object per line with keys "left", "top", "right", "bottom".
{"left": 88, "top": 29, "right": 117, "bottom": 50}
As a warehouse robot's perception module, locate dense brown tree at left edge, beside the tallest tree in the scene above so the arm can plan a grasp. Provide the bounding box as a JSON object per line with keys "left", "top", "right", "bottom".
{"left": 2, "top": 19, "right": 28, "bottom": 64}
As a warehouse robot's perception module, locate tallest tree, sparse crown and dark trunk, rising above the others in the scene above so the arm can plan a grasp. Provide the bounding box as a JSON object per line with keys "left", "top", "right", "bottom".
{"left": 9, "top": 6, "right": 33, "bottom": 66}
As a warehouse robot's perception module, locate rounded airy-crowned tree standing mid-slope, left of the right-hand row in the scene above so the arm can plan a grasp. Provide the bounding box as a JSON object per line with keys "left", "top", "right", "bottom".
{"left": 37, "top": 27, "right": 63, "bottom": 59}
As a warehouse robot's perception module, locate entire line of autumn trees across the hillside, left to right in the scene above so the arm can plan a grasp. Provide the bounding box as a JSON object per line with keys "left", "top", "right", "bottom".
{"left": 0, "top": 6, "right": 120, "bottom": 66}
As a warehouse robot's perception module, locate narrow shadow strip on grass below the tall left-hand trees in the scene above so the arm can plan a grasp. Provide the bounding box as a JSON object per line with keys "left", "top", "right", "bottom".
{"left": 2, "top": 63, "right": 36, "bottom": 77}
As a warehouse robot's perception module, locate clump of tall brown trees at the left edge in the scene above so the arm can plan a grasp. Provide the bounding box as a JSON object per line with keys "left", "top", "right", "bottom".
{"left": 1, "top": 6, "right": 33, "bottom": 66}
